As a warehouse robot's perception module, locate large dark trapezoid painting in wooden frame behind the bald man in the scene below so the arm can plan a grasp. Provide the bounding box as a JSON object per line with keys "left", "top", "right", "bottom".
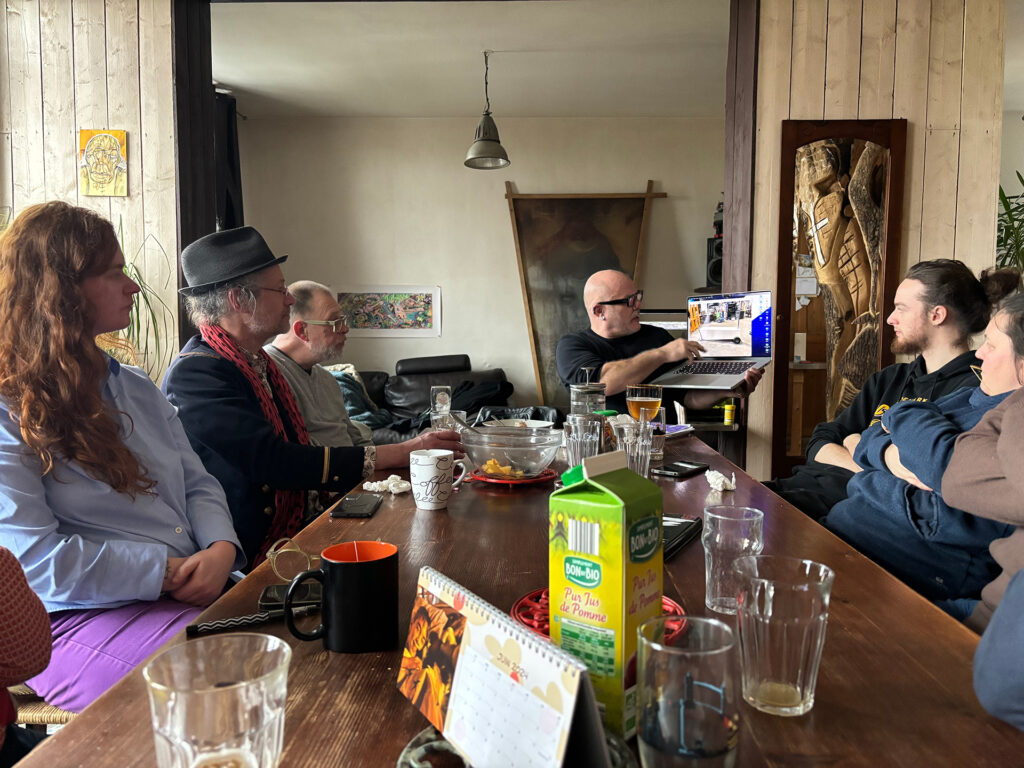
{"left": 505, "top": 181, "right": 667, "bottom": 407}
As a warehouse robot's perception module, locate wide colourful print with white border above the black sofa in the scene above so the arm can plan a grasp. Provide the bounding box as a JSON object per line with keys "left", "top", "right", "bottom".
{"left": 338, "top": 286, "right": 441, "bottom": 338}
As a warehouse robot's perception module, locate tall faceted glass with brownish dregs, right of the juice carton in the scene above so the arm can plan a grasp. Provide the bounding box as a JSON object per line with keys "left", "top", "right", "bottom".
{"left": 733, "top": 555, "right": 836, "bottom": 716}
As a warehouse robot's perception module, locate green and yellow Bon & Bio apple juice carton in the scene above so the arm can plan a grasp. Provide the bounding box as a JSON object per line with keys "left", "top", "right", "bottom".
{"left": 548, "top": 451, "right": 663, "bottom": 738}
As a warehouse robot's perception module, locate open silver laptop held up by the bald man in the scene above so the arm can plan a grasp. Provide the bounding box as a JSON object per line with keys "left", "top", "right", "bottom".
{"left": 650, "top": 291, "right": 772, "bottom": 389}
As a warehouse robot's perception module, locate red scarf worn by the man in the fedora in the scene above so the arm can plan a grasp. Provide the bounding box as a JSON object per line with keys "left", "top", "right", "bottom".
{"left": 199, "top": 326, "right": 309, "bottom": 566}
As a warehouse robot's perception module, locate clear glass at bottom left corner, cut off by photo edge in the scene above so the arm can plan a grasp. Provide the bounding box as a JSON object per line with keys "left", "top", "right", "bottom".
{"left": 142, "top": 633, "right": 292, "bottom": 768}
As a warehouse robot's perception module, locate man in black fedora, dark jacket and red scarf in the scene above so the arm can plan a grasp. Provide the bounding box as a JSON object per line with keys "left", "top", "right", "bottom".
{"left": 164, "top": 226, "right": 459, "bottom": 564}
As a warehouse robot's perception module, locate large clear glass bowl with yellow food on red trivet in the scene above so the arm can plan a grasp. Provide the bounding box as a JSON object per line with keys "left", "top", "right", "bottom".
{"left": 462, "top": 427, "right": 562, "bottom": 479}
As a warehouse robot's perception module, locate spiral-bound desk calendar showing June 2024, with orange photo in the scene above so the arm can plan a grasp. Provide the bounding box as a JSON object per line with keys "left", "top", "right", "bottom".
{"left": 398, "top": 567, "right": 609, "bottom": 768}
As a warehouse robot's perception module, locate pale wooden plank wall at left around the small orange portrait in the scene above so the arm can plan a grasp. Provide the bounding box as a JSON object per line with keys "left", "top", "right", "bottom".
{"left": 0, "top": 0, "right": 178, "bottom": 374}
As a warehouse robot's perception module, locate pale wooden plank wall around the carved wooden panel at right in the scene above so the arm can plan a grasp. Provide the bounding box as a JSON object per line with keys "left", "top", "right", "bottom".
{"left": 746, "top": 0, "right": 1006, "bottom": 479}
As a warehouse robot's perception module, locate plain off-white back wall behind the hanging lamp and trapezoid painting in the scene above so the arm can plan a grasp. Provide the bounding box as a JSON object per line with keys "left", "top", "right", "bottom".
{"left": 239, "top": 115, "right": 724, "bottom": 403}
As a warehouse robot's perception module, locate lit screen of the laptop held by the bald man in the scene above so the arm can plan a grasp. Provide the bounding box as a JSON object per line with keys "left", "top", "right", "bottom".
{"left": 686, "top": 291, "right": 772, "bottom": 357}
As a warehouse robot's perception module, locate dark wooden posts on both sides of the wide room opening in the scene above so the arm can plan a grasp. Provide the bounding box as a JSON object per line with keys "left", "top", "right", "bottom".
{"left": 171, "top": 0, "right": 761, "bottom": 344}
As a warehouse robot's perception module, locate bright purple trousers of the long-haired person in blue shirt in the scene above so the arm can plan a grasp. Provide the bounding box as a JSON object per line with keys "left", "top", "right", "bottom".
{"left": 26, "top": 598, "right": 203, "bottom": 712}
